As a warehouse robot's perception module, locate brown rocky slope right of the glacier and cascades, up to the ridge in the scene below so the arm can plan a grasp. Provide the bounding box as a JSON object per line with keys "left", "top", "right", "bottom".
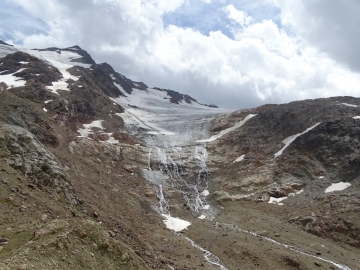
{"left": 210, "top": 97, "right": 360, "bottom": 248}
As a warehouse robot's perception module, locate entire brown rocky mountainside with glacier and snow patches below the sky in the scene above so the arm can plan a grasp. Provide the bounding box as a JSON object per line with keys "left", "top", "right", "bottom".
{"left": 0, "top": 42, "right": 360, "bottom": 269}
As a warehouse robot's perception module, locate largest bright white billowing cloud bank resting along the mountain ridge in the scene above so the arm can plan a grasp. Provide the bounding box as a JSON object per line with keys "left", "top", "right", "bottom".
{"left": 0, "top": 0, "right": 360, "bottom": 108}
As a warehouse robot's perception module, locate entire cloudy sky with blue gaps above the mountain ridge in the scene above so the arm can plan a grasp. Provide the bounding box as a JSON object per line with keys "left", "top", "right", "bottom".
{"left": 0, "top": 0, "right": 360, "bottom": 109}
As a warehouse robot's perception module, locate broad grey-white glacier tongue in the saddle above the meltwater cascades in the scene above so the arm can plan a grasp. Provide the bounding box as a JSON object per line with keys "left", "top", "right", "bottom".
{"left": 112, "top": 88, "right": 231, "bottom": 147}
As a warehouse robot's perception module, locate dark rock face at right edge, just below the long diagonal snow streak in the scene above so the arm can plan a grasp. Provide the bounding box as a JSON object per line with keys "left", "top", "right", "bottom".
{"left": 278, "top": 117, "right": 360, "bottom": 183}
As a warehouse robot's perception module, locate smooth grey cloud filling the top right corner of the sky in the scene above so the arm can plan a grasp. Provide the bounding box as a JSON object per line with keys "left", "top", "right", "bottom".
{"left": 272, "top": 0, "right": 360, "bottom": 71}
